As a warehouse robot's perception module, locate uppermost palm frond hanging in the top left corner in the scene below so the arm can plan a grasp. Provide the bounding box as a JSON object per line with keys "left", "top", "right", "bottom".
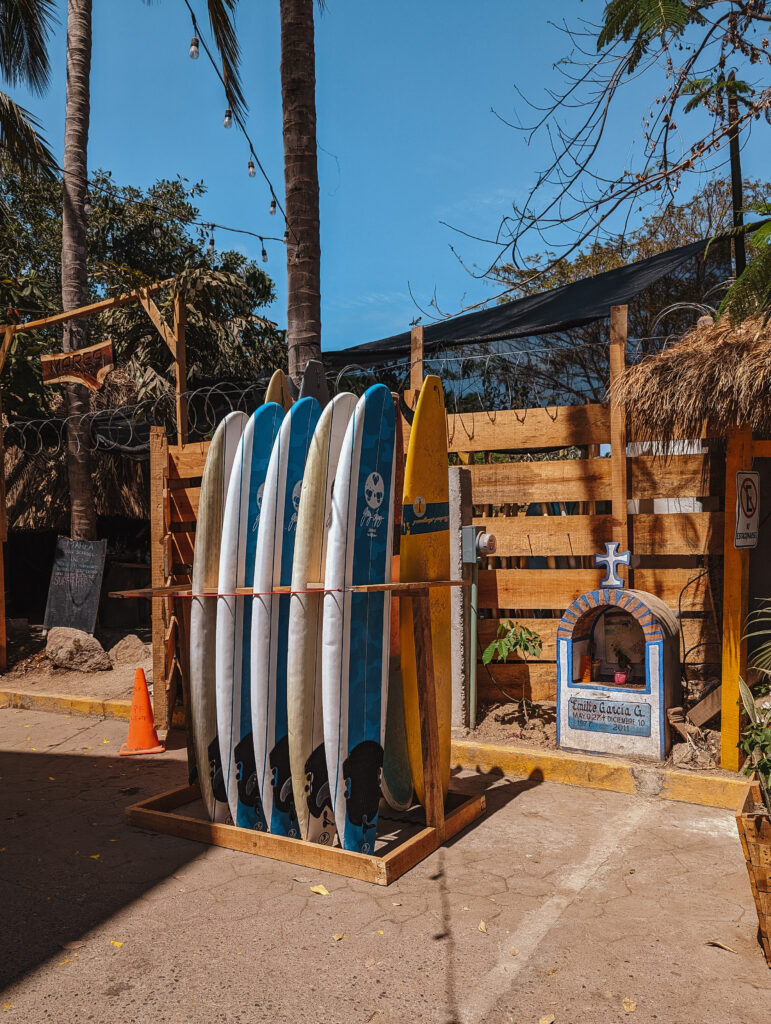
{"left": 0, "top": 0, "right": 57, "bottom": 94}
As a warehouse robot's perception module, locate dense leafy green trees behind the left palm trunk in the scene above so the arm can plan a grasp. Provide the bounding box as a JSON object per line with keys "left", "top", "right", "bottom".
{"left": 0, "top": 171, "right": 286, "bottom": 417}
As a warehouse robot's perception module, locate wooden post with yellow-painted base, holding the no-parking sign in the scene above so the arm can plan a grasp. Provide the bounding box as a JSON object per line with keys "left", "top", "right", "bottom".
{"left": 720, "top": 429, "right": 753, "bottom": 771}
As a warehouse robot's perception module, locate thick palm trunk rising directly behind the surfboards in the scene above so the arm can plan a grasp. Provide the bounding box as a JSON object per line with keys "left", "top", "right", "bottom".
{"left": 281, "top": 0, "right": 322, "bottom": 383}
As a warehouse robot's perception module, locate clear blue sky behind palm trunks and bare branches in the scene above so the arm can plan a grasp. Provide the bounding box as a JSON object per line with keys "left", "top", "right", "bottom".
{"left": 9, "top": 0, "right": 762, "bottom": 348}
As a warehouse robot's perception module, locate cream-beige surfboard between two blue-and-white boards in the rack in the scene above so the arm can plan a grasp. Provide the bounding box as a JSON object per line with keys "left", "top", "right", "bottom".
{"left": 287, "top": 392, "right": 356, "bottom": 845}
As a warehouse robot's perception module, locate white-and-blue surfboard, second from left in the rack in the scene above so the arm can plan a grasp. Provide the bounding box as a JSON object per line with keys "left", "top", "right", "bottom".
{"left": 216, "top": 401, "right": 284, "bottom": 829}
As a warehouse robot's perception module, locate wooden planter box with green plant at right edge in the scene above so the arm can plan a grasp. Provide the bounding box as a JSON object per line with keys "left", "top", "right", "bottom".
{"left": 736, "top": 679, "right": 771, "bottom": 967}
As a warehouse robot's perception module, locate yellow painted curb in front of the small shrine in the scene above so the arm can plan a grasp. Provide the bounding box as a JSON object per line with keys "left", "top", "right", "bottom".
{"left": 453, "top": 739, "right": 746, "bottom": 810}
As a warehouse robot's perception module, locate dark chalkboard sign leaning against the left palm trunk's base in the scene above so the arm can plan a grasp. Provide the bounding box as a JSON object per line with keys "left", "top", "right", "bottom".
{"left": 43, "top": 537, "right": 108, "bottom": 633}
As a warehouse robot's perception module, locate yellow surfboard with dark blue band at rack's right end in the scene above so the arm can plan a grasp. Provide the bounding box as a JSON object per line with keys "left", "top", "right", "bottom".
{"left": 399, "top": 377, "right": 453, "bottom": 803}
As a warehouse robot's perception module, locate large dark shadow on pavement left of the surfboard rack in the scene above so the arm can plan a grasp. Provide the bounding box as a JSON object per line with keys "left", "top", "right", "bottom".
{"left": 0, "top": 751, "right": 192, "bottom": 986}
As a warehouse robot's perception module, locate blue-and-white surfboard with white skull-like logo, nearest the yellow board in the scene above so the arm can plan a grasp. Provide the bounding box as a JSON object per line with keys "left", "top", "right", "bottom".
{"left": 322, "top": 384, "right": 395, "bottom": 853}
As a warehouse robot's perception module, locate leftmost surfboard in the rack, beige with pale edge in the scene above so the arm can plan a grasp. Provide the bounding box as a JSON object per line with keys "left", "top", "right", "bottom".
{"left": 190, "top": 413, "right": 249, "bottom": 821}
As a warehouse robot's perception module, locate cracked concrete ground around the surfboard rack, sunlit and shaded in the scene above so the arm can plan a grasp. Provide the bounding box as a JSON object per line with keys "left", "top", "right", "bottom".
{"left": 0, "top": 709, "right": 771, "bottom": 1024}
